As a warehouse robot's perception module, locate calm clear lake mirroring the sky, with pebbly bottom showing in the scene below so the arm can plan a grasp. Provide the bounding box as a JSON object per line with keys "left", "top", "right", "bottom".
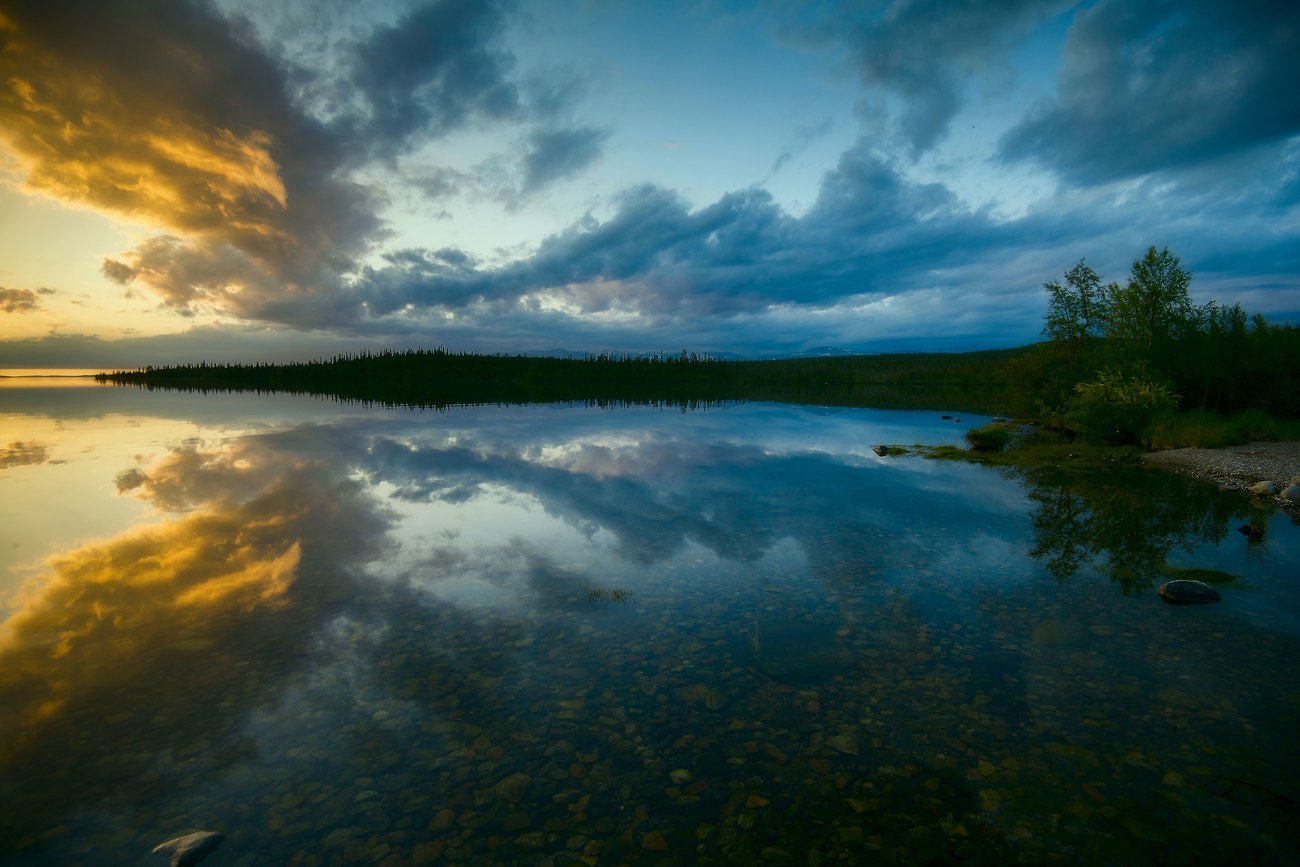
{"left": 0, "top": 387, "right": 1300, "bottom": 867}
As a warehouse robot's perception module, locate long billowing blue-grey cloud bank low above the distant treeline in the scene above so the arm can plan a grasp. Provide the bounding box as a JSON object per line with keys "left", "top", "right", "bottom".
{"left": 355, "top": 142, "right": 998, "bottom": 321}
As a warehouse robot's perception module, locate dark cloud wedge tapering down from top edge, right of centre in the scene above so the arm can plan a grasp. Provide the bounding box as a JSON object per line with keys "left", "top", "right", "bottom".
{"left": 815, "top": 0, "right": 1069, "bottom": 156}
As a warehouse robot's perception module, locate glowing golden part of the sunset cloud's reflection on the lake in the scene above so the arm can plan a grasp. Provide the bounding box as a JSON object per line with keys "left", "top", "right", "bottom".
{"left": 0, "top": 438, "right": 382, "bottom": 763}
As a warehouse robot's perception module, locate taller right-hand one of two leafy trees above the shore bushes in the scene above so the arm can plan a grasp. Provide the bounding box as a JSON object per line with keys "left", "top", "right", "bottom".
{"left": 1106, "top": 247, "right": 1195, "bottom": 350}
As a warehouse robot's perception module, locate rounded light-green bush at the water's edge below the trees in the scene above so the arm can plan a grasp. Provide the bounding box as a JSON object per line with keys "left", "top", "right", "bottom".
{"left": 1067, "top": 367, "right": 1178, "bottom": 446}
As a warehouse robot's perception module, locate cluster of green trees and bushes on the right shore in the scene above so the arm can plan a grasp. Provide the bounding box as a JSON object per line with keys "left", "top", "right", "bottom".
{"left": 1015, "top": 247, "right": 1300, "bottom": 442}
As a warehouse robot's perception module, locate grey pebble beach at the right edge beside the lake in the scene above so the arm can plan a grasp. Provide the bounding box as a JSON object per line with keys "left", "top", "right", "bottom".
{"left": 1143, "top": 442, "right": 1300, "bottom": 517}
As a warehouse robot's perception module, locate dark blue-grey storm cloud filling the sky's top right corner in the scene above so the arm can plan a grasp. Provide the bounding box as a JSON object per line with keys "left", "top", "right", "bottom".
{"left": 1000, "top": 0, "right": 1300, "bottom": 185}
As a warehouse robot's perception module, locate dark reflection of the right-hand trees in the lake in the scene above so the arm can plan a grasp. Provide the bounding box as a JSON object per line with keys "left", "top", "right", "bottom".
{"left": 1010, "top": 467, "right": 1251, "bottom": 594}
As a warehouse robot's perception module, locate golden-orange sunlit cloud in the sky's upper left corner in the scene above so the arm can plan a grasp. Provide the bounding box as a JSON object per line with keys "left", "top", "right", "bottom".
{"left": 0, "top": 1, "right": 378, "bottom": 317}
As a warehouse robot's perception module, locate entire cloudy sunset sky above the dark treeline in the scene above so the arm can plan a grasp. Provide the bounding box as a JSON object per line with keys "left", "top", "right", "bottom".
{"left": 0, "top": 0, "right": 1300, "bottom": 368}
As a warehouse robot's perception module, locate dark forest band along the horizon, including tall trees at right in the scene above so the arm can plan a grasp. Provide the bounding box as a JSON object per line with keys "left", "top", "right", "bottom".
{"left": 99, "top": 247, "right": 1300, "bottom": 446}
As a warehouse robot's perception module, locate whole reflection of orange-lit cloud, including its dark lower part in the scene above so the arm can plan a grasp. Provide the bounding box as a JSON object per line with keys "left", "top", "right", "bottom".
{"left": 0, "top": 437, "right": 389, "bottom": 836}
